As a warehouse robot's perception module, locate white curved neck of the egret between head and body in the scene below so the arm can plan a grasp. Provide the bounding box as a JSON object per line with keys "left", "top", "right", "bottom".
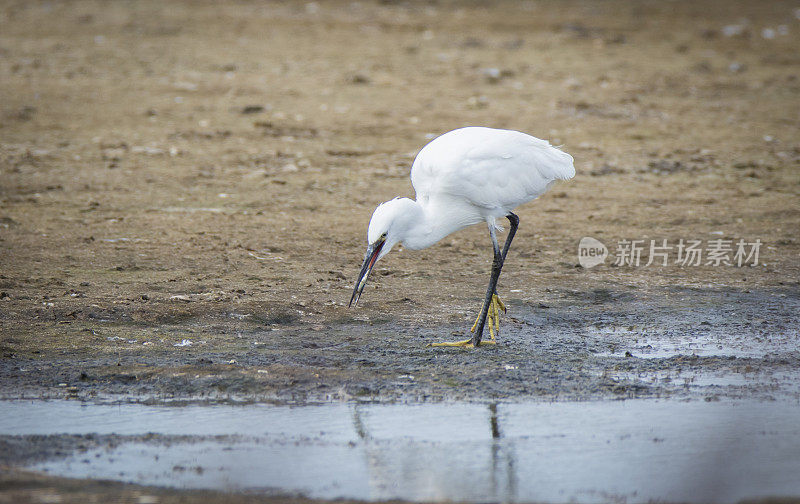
{"left": 400, "top": 197, "right": 485, "bottom": 250}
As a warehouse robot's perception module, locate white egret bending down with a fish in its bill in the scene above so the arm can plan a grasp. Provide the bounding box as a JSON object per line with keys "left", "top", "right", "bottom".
{"left": 350, "top": 127, "right": 575, "bottom": 347}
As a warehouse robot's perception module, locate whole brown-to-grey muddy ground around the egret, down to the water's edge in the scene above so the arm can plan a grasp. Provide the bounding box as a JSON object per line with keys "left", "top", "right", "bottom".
{"left": 0, "top": 0, "right": 800, "bottom": 498}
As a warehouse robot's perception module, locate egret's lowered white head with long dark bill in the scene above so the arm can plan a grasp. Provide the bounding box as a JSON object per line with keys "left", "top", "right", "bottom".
{"left": 348, "top": 198, "right": 417, "bottom": 306}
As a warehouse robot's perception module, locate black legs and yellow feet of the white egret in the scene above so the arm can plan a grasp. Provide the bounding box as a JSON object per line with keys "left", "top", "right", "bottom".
{"left": 431, "top": 213, "right": 519, "bottom": 347}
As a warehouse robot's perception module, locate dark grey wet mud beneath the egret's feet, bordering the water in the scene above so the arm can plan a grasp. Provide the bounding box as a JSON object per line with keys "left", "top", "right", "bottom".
{"left": 0, "top": 286, "right": 800, "bottom": 404}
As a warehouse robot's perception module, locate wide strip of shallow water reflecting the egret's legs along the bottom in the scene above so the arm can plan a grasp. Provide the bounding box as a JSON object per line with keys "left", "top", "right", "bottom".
{"left": 0, "top": 400, "right": 800, "bottom": 503}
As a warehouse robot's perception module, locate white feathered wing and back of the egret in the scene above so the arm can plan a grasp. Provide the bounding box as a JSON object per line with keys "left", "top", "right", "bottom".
{"left": 411, "top": 127, "right": 575, "bottom": 212}
